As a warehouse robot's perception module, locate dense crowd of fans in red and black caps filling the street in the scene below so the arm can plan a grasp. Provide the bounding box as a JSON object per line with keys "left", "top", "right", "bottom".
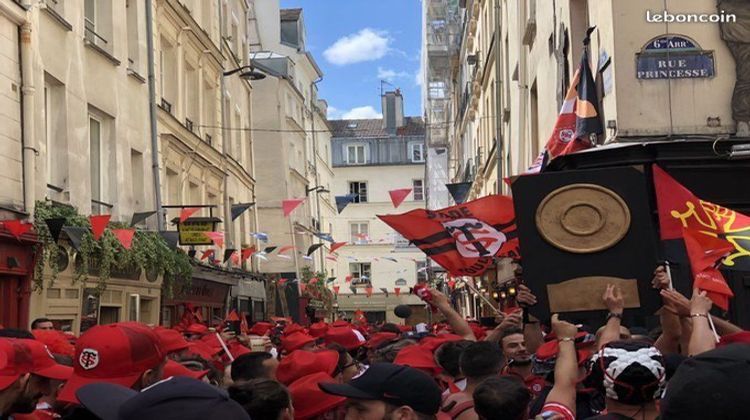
{"left": 0, "top": 269, "right": 750, "bottom": 420}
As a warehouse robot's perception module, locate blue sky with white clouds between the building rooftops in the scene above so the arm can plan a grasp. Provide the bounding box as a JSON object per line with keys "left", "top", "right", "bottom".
{"left": 281, "top": 0, "right": 422, "bottom": 118}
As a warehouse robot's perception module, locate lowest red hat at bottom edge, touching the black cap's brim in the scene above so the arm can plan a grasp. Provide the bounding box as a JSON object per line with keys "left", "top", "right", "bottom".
{"left": 289, "top": 372, "right": 346, "bottom": 420}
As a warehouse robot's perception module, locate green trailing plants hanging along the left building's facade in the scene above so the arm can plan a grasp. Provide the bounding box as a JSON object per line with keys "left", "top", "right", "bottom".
{"left": 34, "top": 201, "right": 192, "bottom": 296}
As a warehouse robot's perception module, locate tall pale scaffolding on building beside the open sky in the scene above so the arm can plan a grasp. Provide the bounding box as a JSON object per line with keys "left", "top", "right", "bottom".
{"left": 422, "top": 0, "right": 461, "bottom": 210}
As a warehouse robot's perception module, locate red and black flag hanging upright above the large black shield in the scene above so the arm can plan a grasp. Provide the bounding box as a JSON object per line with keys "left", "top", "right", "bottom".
{"left": 526, "top": 27, "right": 604, "bottom": 174}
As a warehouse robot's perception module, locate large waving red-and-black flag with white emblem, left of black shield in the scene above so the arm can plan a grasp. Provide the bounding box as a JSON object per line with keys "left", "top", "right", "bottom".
{"left": 378, "top": 195, "right": 518, "bottom": 276}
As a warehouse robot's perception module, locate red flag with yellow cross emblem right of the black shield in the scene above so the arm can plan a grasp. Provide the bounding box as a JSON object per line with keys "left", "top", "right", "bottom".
{"left": 653, "top": 165, "right": 750, "bottom": 267}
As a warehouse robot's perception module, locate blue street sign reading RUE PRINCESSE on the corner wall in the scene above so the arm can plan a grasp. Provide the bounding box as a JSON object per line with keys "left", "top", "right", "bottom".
{"left": 636, "top": 35, "right": 715, "bottom": 80}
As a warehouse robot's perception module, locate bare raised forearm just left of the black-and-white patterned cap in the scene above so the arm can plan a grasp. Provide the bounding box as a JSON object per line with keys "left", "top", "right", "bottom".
{"left": 544, "top": 314, "right": 578, "bottom": 416}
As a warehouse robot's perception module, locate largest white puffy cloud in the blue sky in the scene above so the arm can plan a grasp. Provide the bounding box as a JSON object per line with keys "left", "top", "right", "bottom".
{"left": 323, "top": 28, "right": 391, "bottom": 66}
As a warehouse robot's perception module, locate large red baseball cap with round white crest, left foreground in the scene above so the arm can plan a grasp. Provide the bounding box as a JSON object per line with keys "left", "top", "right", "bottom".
{"left": 57, "top": 323, "right": 164, "bottom": 404}
